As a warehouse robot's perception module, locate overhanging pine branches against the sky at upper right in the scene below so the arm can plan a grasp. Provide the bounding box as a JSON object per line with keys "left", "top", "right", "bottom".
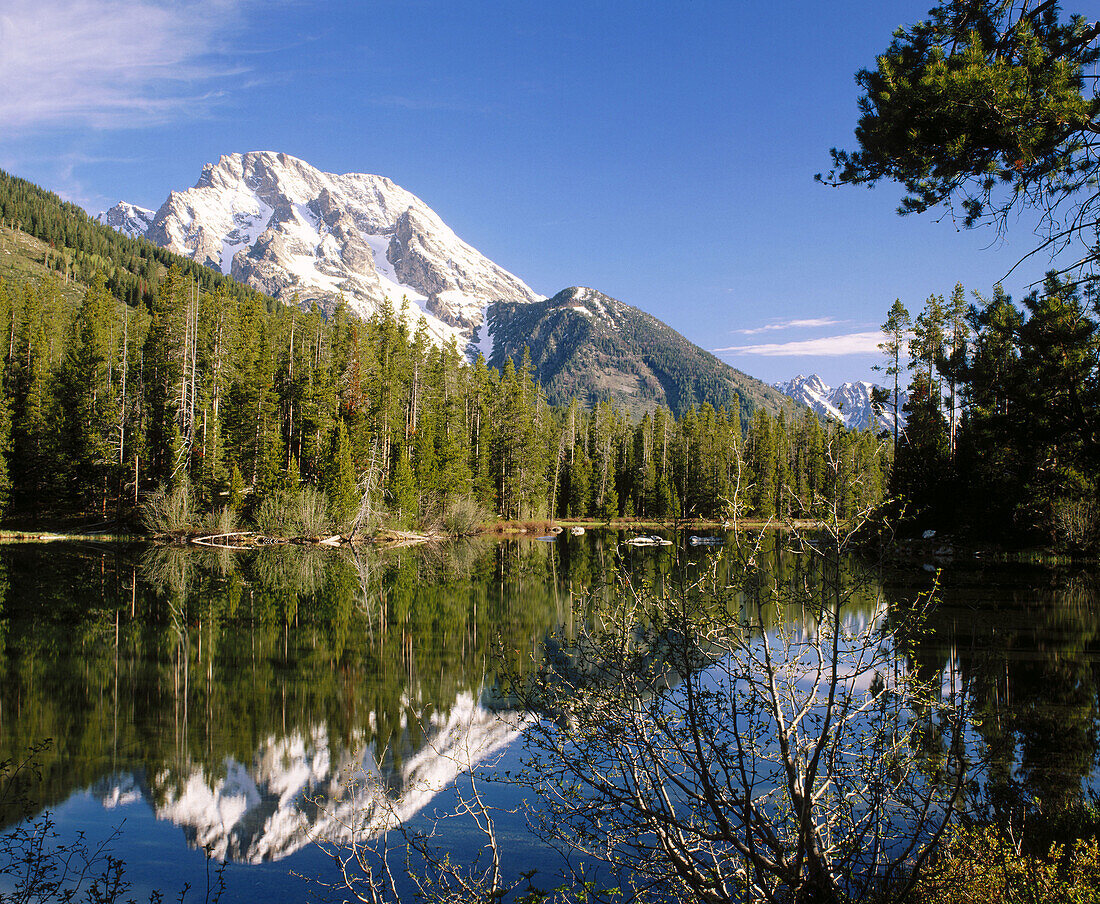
{"left": 828, "top": 0, "right": 1100, "bottom": 240}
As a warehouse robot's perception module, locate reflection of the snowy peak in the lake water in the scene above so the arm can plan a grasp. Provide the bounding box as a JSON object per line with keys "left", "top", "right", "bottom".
{"left": 91, "top": 693, "right": 528, "bottom": 863}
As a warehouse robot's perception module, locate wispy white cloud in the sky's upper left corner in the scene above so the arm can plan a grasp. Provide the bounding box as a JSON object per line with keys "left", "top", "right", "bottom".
{"left": 0, "top": 0, "right": 244, "bottom": 132}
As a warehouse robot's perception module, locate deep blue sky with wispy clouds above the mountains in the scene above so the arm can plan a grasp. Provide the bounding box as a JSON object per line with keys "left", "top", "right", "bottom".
{"left": 0, "top": 0, "right": 1060, "bottom": 385}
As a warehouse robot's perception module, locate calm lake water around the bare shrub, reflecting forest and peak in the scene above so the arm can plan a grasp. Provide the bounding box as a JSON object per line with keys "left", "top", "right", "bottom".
{"left": 0, "top": 532, "right": 1100, "bottom": 903}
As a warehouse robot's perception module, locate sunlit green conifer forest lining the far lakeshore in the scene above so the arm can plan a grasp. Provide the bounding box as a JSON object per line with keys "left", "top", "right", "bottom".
{"left": 0, "top": 173, "right": 887, "bottom": 534}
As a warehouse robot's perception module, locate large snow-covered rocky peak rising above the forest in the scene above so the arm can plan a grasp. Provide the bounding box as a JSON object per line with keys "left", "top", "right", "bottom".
{"left": 103, "top": 151, "right": 542, "bottom": 348}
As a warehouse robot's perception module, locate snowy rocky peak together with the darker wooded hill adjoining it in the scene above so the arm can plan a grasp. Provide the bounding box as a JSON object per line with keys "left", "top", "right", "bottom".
{"left": 99, "top": 152, "right": 785, "bottom": 420}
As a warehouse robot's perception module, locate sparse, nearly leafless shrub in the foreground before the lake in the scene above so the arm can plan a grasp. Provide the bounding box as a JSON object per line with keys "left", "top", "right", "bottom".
{"left": 503, "top": 459, "right": 968, "bottom": 904}
